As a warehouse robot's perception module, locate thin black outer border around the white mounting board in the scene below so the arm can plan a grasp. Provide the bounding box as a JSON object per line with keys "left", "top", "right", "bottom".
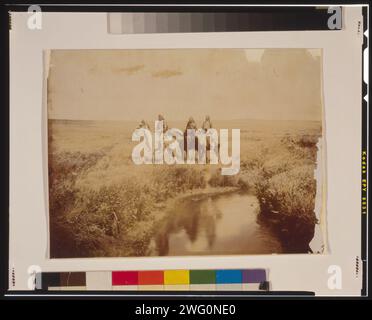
{"left": 0, "top": 0, "right": 371, "bottom": 300}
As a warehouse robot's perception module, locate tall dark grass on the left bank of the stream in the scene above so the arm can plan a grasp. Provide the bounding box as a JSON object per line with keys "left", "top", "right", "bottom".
{"left": 49, "top": 152, "right": 206, "bottom": 257}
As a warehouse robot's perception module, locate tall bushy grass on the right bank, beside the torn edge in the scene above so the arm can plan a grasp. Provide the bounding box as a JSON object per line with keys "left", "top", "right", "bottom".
{"left": 255, "top": 136, "right": 318, "bottom": 252}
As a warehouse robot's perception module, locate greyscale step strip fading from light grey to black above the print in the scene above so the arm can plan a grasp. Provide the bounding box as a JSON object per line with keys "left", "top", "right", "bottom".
{"left": 107, "top": 7, "right": 340, "bottom": 34}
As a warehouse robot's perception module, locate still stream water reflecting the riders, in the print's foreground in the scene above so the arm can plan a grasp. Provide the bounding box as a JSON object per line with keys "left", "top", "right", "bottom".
{"left": 152, "top": 194, "right": 282, "bottom": 256}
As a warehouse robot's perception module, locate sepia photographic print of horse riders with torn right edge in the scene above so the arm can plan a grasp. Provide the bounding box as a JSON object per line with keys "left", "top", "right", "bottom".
{"left": 46, "top": 48, "right": 324, "bottom": 258}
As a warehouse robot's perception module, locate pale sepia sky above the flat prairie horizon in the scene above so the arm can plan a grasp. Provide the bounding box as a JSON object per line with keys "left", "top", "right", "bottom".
{"left": 48, "top": 49, "right": 322, "bottom": 122}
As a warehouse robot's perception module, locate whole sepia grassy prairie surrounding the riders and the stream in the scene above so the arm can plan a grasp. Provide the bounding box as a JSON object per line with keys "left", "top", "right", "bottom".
{"left": 49, "top": 120, "right": 321, "bottom": 257}
